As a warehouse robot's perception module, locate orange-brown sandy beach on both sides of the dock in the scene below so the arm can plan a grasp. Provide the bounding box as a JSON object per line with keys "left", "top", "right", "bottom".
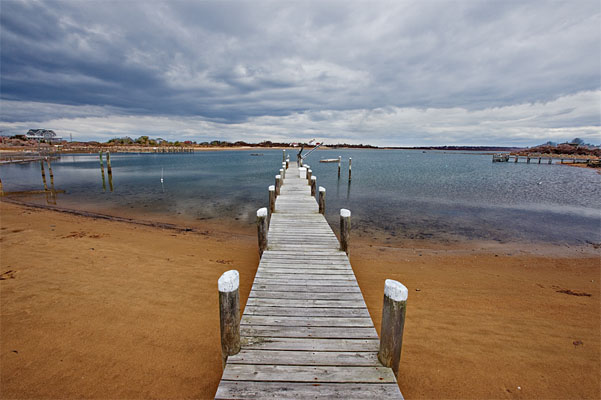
{"left": 0, "top": 202, "right": 601, "bottom": 399}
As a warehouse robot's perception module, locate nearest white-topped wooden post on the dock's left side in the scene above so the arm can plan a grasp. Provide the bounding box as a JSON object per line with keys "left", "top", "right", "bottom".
{"left": 217, "top": 269, "right": 240, "bottom": 367}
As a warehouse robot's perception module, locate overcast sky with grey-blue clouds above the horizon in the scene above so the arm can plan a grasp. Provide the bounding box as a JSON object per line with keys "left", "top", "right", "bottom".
{"left": 0, "top": 0, "right": 601, "bottom": 146}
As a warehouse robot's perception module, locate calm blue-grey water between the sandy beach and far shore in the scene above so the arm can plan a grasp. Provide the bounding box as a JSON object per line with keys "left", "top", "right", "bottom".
{"left": 0, "top": 150, "right": 601, "bottom": 243}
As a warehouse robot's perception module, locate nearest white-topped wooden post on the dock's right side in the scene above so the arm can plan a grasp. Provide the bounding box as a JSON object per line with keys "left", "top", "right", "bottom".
{"left": 378, "top": 279, "right": 409, "bottom": 376}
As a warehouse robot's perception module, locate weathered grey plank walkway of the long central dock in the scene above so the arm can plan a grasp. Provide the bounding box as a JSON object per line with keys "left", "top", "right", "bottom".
{"left": 215, "top": 163, "right": 402, "bottom": 399}
